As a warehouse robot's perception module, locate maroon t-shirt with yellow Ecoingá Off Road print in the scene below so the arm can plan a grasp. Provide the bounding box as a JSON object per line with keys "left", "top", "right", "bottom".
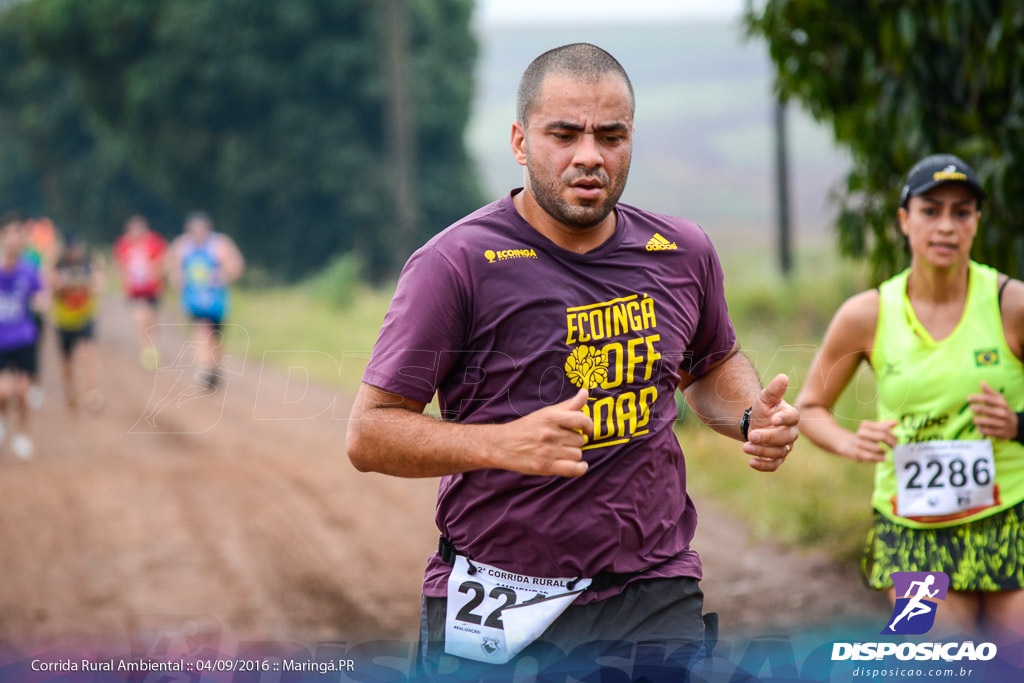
{"left": 364, "top": 190, "right": 735, "bottom": 603}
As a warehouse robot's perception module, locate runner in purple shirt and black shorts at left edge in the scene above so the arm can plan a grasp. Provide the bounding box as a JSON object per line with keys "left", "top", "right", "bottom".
{"left": 0, "top": 213, "right": 42, "bottom": 460}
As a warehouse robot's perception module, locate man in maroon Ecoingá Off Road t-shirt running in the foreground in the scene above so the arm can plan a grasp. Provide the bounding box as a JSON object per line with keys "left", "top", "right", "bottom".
{"left": 348, "top": 44, "right": 799, "bottom": 674}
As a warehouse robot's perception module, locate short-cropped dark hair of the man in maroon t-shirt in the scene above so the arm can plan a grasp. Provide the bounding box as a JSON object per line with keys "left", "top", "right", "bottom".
{"left": 515, "top": 43, "right": 636, "bottom": 126}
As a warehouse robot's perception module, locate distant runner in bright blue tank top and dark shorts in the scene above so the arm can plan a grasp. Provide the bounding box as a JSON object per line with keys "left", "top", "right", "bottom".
{"left": 168, "top": 211, "right": 245, "bottom": 389}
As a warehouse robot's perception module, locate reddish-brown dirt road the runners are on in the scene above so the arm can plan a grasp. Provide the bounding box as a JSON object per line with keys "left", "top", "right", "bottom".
{"left": 0, "top": 301, "right": 886, "bottom": 650}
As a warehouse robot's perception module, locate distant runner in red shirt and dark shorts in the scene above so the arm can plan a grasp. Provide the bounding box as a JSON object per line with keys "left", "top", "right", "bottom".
{"left": 114, "top": 214, "right": 167, "bottom": 370}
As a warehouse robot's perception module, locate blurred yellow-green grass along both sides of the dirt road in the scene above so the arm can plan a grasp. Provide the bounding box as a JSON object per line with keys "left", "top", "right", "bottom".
{"left": 228, "top": 242, "right": 873, "bottom": 560}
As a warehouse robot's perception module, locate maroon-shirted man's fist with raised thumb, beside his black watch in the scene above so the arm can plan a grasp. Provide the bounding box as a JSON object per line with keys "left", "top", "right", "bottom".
{"left": 743, "top": 375, "right": 800, "bottom": 472}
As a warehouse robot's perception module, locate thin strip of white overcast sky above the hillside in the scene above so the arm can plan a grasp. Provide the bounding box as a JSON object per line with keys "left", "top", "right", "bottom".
{"left": 475, "top": 0, "right": 744, "bottom": 26}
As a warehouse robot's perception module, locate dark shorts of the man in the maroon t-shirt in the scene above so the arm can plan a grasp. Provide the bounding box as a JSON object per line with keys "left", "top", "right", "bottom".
{"left": 417, "top": 577, "right": 718, "bottom": 680}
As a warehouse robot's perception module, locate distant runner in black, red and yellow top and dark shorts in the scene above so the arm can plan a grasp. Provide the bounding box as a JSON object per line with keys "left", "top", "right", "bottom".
{"left": 50, "top": 236, "right": 103, "bottom": 413}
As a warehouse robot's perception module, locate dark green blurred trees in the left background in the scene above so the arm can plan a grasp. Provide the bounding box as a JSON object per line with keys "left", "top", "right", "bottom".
{"left": 0, "top": 0, "right": 480, "bottom": 276}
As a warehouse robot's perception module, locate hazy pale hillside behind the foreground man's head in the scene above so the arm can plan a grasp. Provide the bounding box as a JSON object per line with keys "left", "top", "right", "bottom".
{"left": 469, "top": 25, "right": 848, "bottom": 238}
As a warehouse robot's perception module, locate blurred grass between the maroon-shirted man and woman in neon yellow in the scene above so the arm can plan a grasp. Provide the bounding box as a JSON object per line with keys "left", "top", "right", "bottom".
{"left": 692, "top": 240, "right": 874, "bottom": 561}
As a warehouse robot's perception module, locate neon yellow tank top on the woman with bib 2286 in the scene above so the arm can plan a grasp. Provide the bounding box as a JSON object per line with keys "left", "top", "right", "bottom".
{"left": 870, "top": 261, "right": 1024, "bottom": 528}
